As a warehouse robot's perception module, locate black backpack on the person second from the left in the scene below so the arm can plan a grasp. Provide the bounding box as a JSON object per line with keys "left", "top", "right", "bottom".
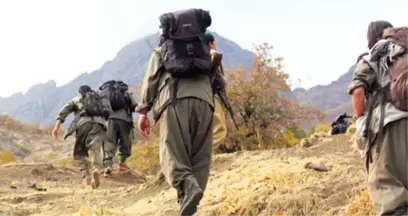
{"left": 99, "top": 80, "right": 129, "bottom": 110}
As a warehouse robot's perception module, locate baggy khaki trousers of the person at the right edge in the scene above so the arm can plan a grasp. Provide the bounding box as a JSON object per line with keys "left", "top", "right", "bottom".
{"left": 368, "top": 118, "right": 408, "bottom": 216}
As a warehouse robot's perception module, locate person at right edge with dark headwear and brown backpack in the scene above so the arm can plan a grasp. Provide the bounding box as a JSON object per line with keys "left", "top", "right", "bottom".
{"left": 348, "top": 21, "right": 408, "bottom": 216}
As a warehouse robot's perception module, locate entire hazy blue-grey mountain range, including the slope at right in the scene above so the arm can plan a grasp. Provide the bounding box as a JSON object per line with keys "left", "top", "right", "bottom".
{"left": 0, "top": 32, "right": 353, "bottom": 125}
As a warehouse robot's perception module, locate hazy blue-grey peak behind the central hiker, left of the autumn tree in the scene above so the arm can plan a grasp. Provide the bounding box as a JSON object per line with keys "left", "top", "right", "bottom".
{"left": 0, "top": 33, "right": 254, "bottom": 125}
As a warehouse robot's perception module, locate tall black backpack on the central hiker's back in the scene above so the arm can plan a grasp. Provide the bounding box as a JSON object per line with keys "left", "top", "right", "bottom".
{"left": 159, "top": 9, "right": 212, "bottom": 77}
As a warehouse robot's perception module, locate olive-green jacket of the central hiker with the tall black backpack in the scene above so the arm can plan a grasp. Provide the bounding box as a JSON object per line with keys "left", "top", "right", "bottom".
{"left": 136, "top": 48, "right": 214, "bottom": 121}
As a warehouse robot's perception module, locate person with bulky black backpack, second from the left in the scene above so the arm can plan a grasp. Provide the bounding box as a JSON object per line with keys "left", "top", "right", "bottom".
{"left": 99, "top": 80, "right": 137, "bottom": 177}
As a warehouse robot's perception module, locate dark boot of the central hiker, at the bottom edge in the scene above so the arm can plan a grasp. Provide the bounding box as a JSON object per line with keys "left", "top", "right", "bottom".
{"left": 178, "top": 182, "right": 204, "bottom": 216}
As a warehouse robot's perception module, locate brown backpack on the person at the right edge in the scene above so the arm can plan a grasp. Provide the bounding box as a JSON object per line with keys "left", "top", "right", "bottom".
{"left": 383, "top": 27, "right": 408, "bottom": 111}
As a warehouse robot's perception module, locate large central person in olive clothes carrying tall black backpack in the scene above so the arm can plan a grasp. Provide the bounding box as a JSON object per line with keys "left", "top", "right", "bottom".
{"left": 136, "top": 9, "right": 214, "bottom": 216}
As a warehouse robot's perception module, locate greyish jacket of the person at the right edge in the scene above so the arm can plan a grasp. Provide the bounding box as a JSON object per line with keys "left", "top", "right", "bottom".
{"left": 347, "top": 40, "right": 408, "bottom": 133}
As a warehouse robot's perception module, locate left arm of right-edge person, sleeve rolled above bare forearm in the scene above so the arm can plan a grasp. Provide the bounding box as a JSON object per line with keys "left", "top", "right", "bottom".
{"left": 348, "top": 59, "right": 376, "bottom": 118}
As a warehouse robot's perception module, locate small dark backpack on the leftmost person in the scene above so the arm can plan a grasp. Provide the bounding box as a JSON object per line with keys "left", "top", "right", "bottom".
{"left": 82, "top": 90, "right": 104, "bottom": 116}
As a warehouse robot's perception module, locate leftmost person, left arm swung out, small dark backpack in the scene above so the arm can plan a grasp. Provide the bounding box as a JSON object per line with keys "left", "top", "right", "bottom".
{"left": 52, "top": 85, "right": 112, "bottom": 189}
